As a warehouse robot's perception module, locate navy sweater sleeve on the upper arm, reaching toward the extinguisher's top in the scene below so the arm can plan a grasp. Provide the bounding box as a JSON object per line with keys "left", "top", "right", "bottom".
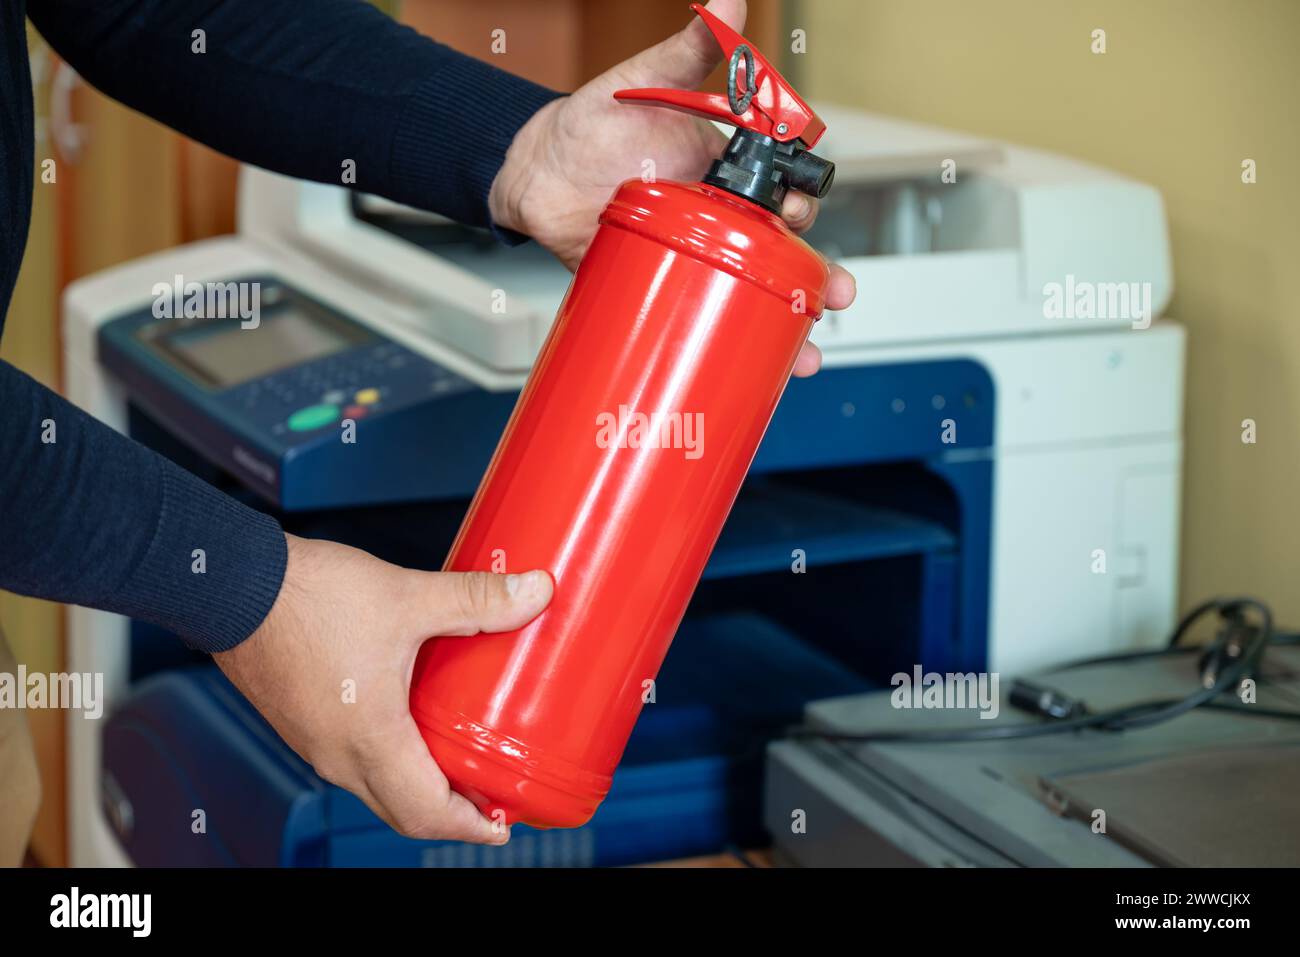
{"left": 29, "top": 0, "right": 559, "bottom": 226}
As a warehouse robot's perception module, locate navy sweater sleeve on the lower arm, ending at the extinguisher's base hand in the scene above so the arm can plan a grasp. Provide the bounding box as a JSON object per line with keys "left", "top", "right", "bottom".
{"left": 0, "top": 361, "right": 287, "bottom": 651}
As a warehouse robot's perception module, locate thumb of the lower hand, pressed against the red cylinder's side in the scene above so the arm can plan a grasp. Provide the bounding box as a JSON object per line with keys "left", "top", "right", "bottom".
{"left": 428, "top": 571, "right": 555, "bottom": 635}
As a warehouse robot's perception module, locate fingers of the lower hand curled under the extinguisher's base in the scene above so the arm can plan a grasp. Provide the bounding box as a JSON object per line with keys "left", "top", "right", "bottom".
{"left": 364, "top": 719, "right": 510, "bottom": 844}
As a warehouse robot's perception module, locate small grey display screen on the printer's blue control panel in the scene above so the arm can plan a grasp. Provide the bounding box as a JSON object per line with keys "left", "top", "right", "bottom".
{"left": 159, "top": 307, "right": 354, "bottom": 387}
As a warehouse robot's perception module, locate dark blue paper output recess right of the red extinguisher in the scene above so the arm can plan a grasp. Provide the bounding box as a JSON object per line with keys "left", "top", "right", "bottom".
{"left": 696, "top": 463, "right": 962, "bottom": 685}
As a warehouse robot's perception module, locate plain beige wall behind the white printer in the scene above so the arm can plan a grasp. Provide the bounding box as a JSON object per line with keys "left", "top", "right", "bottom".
{"left": 790, "top": 0, "right": 1300, "bottom": 625}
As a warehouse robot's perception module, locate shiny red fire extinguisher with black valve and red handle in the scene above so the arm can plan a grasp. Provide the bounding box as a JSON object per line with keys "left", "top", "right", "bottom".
{"left": 411, "top": 4, "right": 835, "bottom": 827}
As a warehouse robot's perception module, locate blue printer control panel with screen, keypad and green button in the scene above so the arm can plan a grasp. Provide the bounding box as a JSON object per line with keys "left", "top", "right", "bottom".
{"left": 99, "top": 276, "right": 514, "bottom": 511}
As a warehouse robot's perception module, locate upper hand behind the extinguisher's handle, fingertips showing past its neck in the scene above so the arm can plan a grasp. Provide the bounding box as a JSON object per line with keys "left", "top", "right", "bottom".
{"left": 488, "top": 0, "right": 855, "bottom": 376}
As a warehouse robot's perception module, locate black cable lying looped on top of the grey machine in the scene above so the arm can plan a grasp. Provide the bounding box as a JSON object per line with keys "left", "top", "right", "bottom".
{"left": 789, "top": 597, "right": 1300, "bottom": 744}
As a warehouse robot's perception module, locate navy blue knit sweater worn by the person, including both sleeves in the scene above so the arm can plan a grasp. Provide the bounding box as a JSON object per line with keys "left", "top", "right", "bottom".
{"left": 0, "top": 0, "right": 558, "bottom": 651}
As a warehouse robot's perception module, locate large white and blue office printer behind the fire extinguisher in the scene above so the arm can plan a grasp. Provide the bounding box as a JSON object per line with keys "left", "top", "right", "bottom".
{"left": 64, "top": 111, "right": 1183, "bottom": 865}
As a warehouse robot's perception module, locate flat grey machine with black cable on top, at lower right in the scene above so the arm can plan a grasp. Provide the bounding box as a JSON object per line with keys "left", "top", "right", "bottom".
{"left": 766, "top": 646, "right": 1300, "bottom": 867}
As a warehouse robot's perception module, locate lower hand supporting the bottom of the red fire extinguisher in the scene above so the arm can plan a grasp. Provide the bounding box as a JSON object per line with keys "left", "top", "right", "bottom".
{"left": 216, "top": 536, "right": 553, "bottom": 844}
